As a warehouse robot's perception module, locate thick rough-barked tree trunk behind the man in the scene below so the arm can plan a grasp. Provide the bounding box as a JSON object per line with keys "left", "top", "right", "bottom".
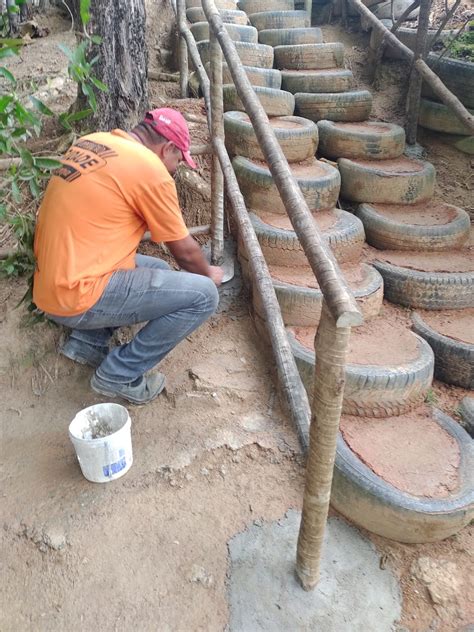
{"left": 76, "top": 0, "right": 148, "bottom": 130}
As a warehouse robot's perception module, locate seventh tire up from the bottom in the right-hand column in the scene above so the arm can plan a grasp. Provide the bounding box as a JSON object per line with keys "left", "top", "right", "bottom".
{"left": 281, "top": 68, "right": 354, "bottom": 94}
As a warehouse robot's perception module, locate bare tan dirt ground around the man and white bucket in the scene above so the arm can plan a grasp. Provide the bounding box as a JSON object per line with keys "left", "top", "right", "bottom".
{"left": 0, "top": 3, "right": 474, "bottom": 632}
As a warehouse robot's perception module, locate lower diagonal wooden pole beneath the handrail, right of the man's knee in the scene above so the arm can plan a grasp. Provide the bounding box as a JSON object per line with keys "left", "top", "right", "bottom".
{"left": 213, "top": 138, "right": 311, "bottom": 444}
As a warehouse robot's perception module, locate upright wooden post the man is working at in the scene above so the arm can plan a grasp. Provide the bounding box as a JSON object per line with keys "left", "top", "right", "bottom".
{"left": 209, "top": 24, "right": 224, "bottom": 265}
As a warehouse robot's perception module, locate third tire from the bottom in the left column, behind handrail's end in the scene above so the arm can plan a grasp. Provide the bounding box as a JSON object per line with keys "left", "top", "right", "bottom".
{"left": 243, "top": 256, "right": 383, "bottom": 327}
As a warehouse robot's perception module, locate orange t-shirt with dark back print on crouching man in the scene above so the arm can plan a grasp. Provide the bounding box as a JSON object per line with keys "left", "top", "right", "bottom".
{"left": 33, "top": 130, "right": 189, "bottom": 316}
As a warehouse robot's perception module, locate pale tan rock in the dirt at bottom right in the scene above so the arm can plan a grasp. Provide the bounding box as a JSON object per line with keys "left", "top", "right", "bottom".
{"left": 411, "top": 557, "right": 462, "bottom": 606}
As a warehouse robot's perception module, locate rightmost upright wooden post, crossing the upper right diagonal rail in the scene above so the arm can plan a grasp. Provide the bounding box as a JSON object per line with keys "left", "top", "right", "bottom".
{"left": 406, "top": 0, "right": 431, "bottom": 145}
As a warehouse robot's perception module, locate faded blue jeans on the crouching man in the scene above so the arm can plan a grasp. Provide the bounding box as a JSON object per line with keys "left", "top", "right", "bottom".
{"left": 47, "top": 255, "right": 219, "bottom": 383}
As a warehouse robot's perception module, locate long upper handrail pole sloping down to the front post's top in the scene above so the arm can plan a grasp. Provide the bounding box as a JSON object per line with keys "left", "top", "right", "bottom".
{"left": 202, "top": 0, "right": 362, "bottom": 334}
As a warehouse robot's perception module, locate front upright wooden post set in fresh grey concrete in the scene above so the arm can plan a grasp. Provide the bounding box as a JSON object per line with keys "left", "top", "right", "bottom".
{"left": 296, "top": 300, "right": 351, "bottom": 590}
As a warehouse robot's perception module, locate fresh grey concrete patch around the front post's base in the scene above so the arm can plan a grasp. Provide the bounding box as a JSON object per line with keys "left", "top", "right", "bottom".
{"left": 229, "top": 511, "right": 401, "bottom": 632}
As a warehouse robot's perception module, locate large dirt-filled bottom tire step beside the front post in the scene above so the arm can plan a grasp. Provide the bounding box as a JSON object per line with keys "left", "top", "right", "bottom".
{"left": 331, "top": 406, "right": 474, "bottom": 543}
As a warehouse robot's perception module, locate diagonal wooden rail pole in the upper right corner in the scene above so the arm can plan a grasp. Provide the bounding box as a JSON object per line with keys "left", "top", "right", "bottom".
{"left": 347, "top": 0, "right": 474, "bottom": 133}
